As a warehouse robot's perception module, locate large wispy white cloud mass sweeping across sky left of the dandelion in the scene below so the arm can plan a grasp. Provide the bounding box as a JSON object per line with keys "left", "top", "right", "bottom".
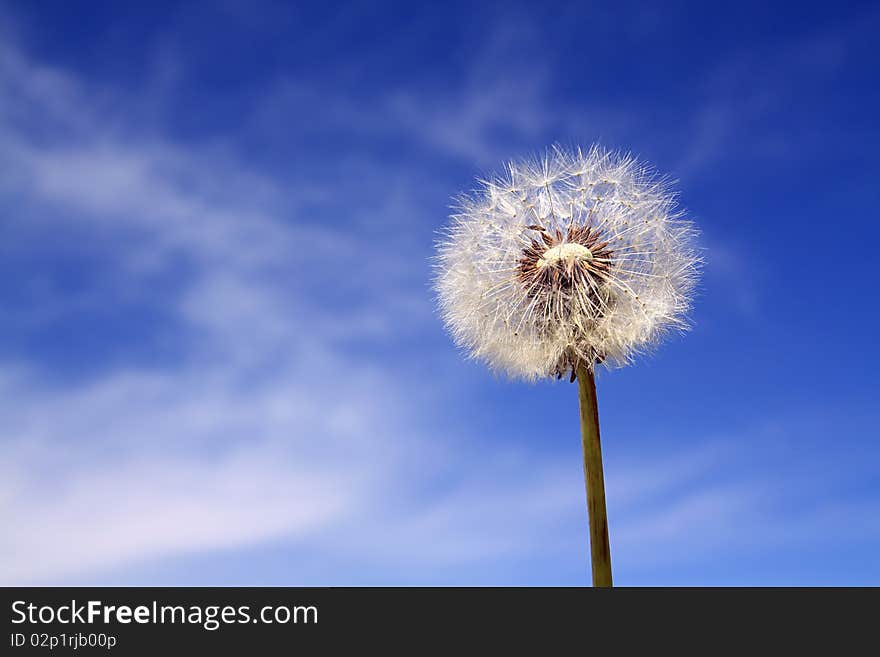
{"left": 0, "top": 32, "right": 580, "bottom": 583}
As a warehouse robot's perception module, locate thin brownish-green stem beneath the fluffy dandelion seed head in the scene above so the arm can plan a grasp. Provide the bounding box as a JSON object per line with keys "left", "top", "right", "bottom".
{"left": 576, "top": 362, "right": 611, "bottom": 587}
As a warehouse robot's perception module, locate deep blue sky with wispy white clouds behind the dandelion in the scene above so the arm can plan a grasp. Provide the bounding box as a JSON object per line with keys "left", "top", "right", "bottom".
{"left": 0, "top": 2, "right": 880, "bottom": 585}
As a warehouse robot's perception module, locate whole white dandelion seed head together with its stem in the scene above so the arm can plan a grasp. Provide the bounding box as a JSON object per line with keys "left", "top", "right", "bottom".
{"left": 436, "top": 146, "right": 700, "bottom": 586}
